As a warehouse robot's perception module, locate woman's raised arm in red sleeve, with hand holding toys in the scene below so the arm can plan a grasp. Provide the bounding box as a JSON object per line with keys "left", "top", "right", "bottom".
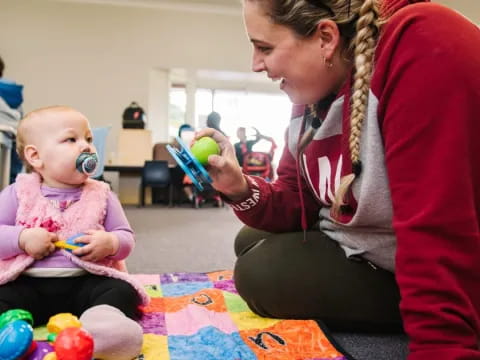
{"left": 196, "top": 130, "right": 320, "bottom": 232}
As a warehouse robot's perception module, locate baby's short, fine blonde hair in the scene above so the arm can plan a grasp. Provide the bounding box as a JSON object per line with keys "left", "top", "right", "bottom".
{"left": 16, "top": 105, "right": 77, "bottom": 173}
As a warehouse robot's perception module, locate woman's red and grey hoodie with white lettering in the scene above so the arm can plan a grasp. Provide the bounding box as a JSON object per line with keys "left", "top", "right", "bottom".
{"left": 228, "top": 0, "right": 480, "bottom": 360}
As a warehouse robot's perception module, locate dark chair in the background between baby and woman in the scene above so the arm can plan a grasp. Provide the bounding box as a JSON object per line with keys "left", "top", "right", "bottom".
{"left": 140, "top": 160, "right": 173, "bottom": 207}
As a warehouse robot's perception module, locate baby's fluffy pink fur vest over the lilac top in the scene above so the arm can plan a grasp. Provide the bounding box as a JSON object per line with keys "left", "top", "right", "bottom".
{"left": 0, "top": 173, "right": 149, "bottom": 304}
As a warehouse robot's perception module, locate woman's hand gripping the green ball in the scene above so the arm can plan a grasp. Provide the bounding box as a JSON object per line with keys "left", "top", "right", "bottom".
{"left": 195, "top": 128, "right": 248, "bottom": 201}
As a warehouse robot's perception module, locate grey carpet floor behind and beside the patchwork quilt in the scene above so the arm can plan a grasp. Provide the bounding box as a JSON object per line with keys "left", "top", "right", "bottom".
{"left": 125, "top": 206, "right": 407, "bottom": 360}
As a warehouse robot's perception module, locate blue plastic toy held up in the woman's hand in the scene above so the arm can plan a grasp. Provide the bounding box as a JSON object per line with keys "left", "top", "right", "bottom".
{"left": 167, "top": 136, "right": 213, "bottom": 191}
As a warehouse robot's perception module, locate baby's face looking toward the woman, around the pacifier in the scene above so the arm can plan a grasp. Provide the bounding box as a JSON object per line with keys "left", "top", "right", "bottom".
{"left": 31, "top": 110, "right": 96, "bottom": 188}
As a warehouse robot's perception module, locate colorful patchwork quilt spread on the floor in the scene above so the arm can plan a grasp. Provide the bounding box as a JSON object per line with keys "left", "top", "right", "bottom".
{"left": 35, "top": 271, "right": 351, "bottom": 360}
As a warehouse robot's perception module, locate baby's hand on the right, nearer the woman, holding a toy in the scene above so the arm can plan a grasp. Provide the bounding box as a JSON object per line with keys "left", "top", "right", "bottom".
{"left": 72, "top": 230, "right": 119, "bottom": 262}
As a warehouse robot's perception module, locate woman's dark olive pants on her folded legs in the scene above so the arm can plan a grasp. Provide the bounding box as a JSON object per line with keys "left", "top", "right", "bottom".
{"left": 234, "top": 227, "right": 402, "bottom": 332}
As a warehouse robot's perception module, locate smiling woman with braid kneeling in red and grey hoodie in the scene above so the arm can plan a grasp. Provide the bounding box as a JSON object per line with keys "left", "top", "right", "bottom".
{"left": 197, "top": 0, "right": 480, "bottom": 360}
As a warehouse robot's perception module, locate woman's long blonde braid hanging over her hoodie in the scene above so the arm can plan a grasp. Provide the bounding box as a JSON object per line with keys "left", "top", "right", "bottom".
{"left": 332, "top": 0, "right": 380, "bottom": 217}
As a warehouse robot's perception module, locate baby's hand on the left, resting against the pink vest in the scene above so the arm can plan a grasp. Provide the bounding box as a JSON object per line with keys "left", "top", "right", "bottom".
{"left": 18, "top": 228, "right": 58, "bottom": 260}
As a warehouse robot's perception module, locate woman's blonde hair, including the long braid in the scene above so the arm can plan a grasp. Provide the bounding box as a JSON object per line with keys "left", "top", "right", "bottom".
{"left": 245, "top": 0, "right": 385, "bottom": 216}
